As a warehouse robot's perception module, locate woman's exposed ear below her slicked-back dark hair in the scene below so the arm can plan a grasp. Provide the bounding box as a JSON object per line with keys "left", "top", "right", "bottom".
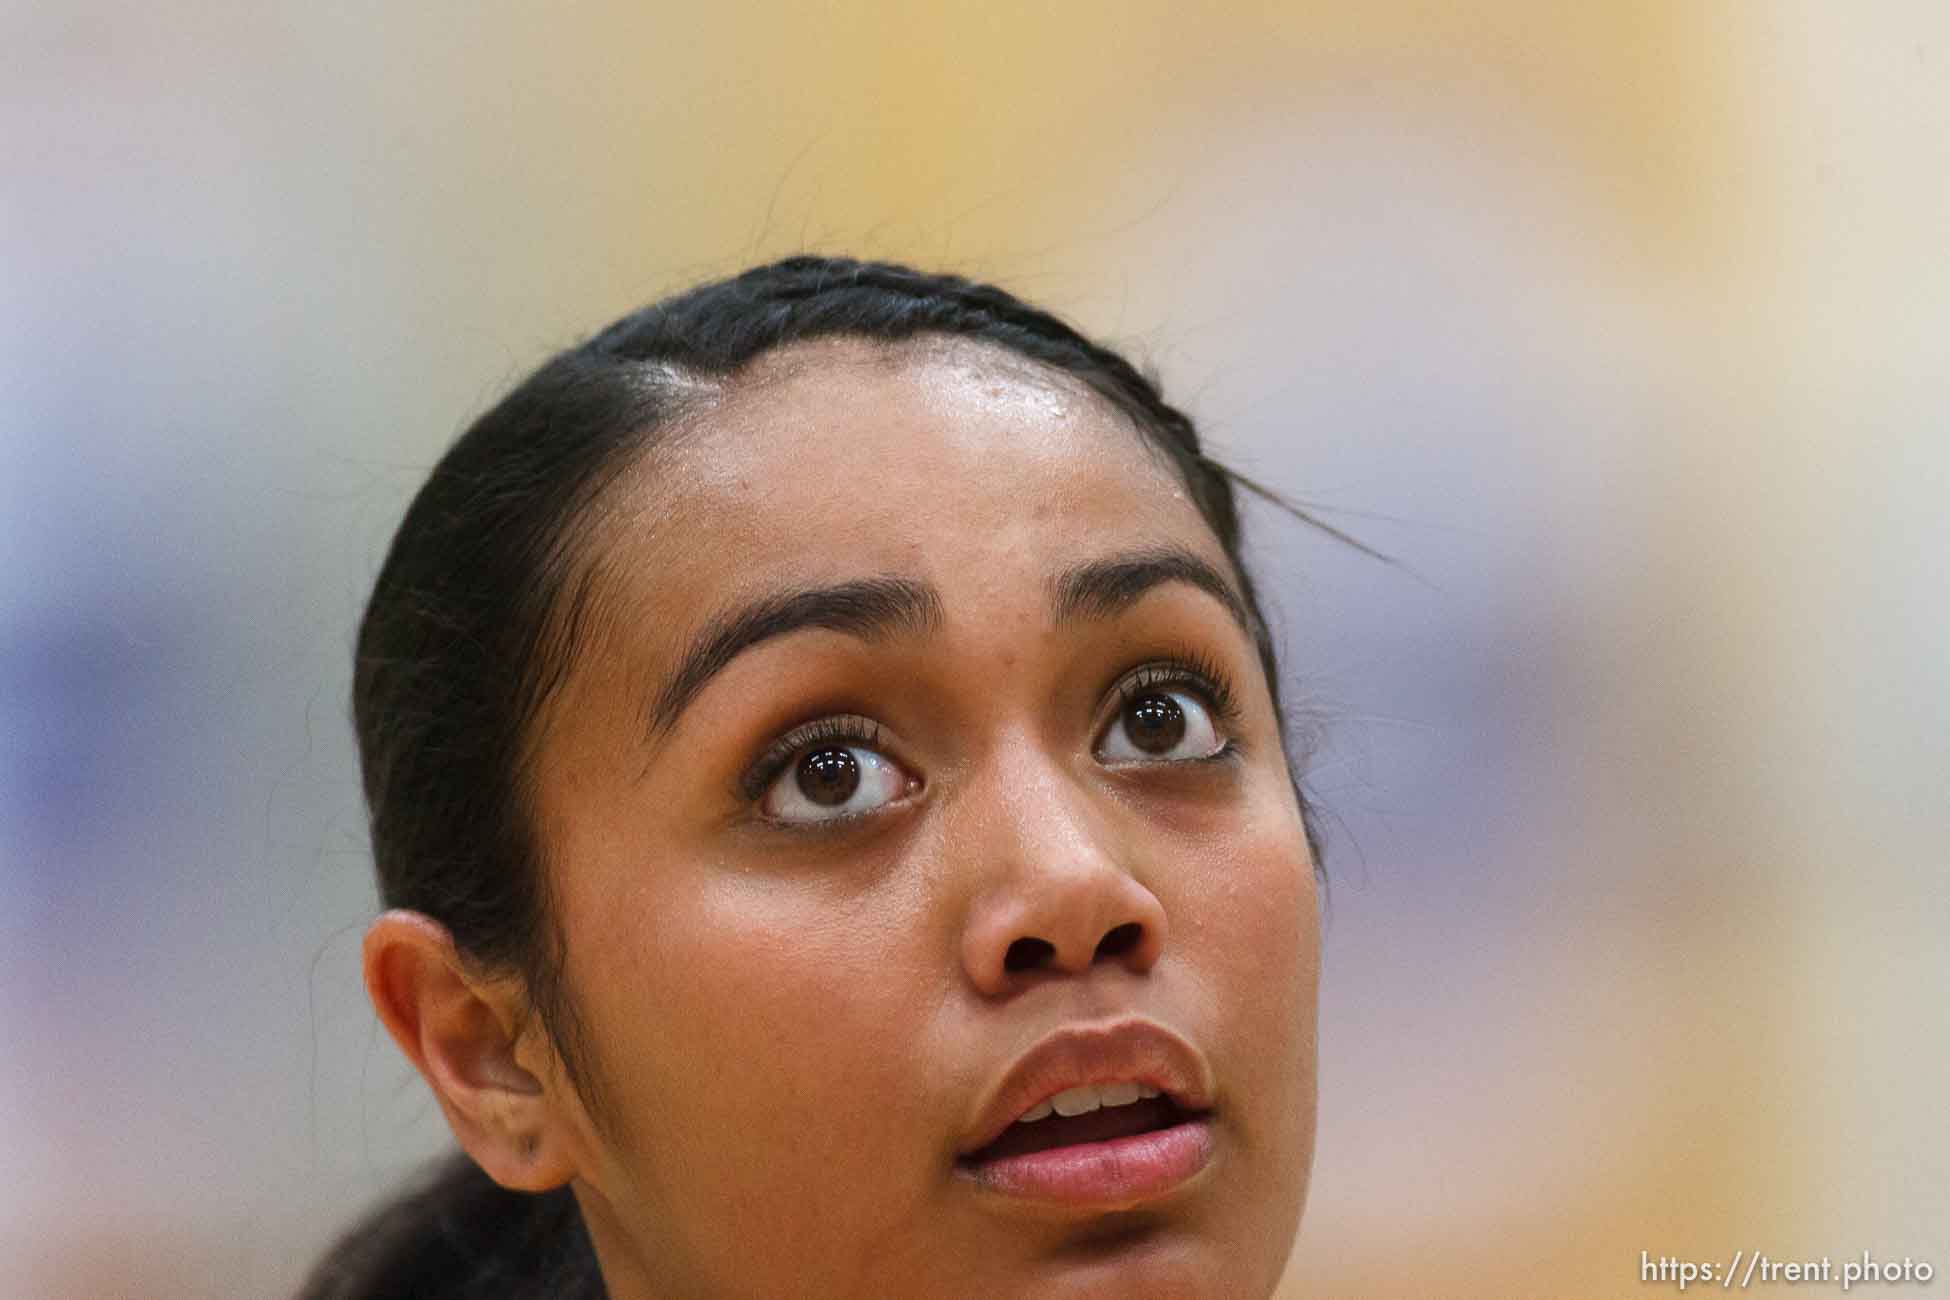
{"left": 365, "top": 910, "right": 575, "bottom": 1191}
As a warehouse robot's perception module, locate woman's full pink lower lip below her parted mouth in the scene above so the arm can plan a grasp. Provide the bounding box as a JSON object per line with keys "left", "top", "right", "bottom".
{"left": 967, "top": 1119, "right": 1213, "bottom": 1208}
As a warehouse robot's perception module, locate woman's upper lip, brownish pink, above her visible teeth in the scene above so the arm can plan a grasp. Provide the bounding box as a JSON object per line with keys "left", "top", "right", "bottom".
{"left": 959, "top": 1017, "right": 1213, "bottom": 1156}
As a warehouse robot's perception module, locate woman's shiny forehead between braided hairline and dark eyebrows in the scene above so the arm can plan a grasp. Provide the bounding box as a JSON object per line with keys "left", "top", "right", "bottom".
{"left": 597, "top": 339, "right": 1229, "bottom": 611}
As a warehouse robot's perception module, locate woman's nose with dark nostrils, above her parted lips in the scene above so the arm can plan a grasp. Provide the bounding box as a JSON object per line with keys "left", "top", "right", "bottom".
{"left": 956, "top": 740, "right": 1166, "bottom": 998}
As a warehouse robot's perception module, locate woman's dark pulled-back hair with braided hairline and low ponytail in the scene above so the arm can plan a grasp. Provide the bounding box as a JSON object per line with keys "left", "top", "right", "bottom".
{"left": 302, "top": 257, "right": 1340, "bottom": 1300}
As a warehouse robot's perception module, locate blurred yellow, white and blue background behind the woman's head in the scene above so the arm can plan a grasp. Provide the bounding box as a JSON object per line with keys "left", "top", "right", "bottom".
{"left": 0, "top": 0, "right": 1950, "bottom": 1300}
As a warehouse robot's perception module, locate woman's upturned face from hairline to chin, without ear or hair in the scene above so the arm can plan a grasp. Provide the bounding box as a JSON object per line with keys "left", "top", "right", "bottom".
{"left": 536, "top": 341, "right": 1318, "bottom": 1298}
